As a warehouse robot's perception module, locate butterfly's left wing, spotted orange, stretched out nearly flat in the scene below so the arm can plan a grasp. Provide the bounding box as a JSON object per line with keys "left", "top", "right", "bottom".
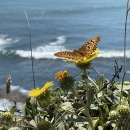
{"left": 54, "top": 50, "right": 83, "bottom": 60}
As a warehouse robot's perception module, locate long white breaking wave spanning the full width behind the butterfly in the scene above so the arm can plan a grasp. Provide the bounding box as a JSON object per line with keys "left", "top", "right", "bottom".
{"left": 0, "top": 48, "right": 130, "bottom": 59}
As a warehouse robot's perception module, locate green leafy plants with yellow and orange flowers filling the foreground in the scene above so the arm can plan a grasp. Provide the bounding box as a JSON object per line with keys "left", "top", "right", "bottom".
{"left": 0, "top": 39, "right": 130, "bottom": 130}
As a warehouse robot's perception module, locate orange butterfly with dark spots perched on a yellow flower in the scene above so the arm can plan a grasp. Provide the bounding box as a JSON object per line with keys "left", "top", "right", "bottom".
{"left": 54, "top": 36, "right": 101, "bottom": 60}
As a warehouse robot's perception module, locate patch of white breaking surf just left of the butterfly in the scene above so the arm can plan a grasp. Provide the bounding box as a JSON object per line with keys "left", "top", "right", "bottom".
{"left": 15, "top": 36, "right": 66, "bottom": 59}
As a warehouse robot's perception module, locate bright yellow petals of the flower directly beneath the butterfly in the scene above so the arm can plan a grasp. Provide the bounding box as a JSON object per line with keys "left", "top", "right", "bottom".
{"left": 65, "top": 48, "right": 99, "bottom": 64}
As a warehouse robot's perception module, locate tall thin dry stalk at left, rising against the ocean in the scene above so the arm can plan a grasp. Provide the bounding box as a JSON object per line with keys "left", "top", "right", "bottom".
{"left": 24, "top": 10, "right": 36, "bottom": 88}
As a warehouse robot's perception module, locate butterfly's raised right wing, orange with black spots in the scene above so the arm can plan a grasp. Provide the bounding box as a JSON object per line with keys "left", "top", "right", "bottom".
{"left": 78, "top": 36, "right": 101, "bottom": 56}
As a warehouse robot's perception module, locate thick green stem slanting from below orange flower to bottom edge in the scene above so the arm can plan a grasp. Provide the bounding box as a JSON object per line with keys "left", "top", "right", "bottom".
{"left": 70, "top": 88, "right": 94, "bottom": 130}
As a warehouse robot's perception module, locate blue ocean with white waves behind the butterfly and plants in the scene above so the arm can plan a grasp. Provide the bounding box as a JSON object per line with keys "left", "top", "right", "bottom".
{"left": 0, "top": 0, "right": 130, "bottom": 90}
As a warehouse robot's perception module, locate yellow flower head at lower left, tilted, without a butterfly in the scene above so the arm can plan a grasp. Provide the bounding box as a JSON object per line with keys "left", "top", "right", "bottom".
{"left": 28, "top": 82, "right": 54, "bottom": 99}
